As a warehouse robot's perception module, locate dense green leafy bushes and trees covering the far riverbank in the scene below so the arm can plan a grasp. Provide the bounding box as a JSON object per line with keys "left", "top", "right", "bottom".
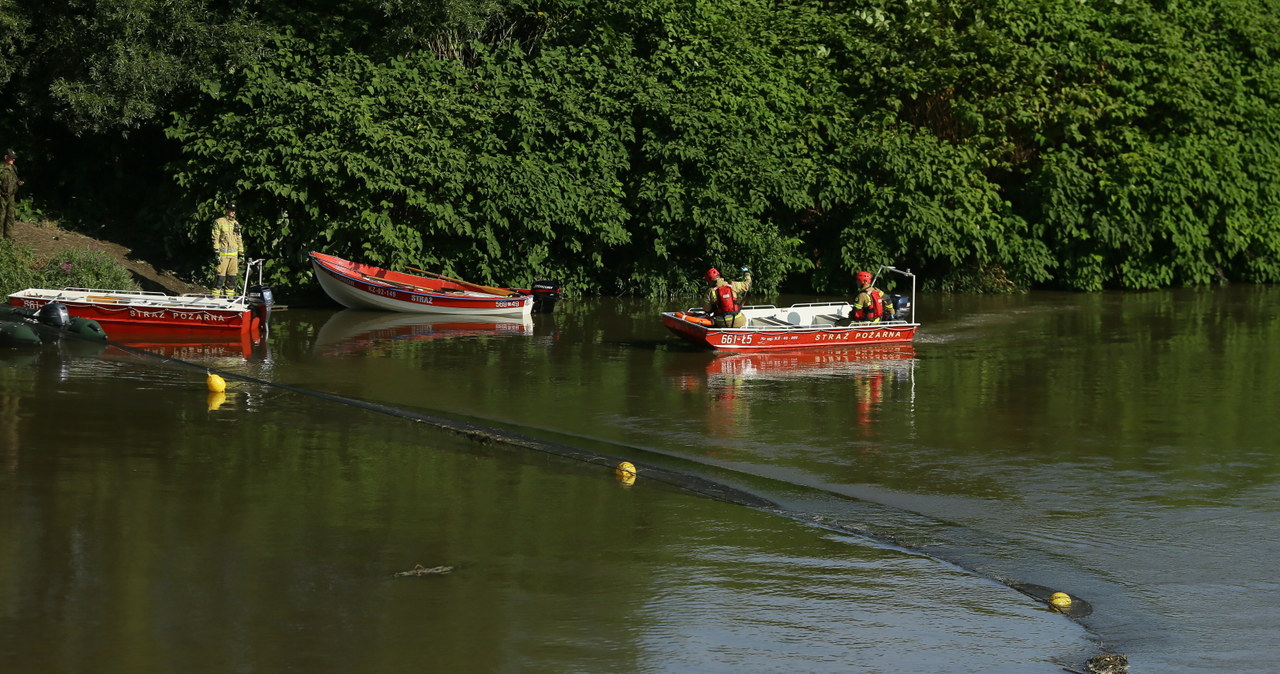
{"left": 0, "top": 0, "right": 1280, "bottom": 297}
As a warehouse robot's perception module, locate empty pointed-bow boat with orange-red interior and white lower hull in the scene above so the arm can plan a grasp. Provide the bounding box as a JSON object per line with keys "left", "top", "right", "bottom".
{"left": 311, "top": 252, "right": 558, "bottom": 317}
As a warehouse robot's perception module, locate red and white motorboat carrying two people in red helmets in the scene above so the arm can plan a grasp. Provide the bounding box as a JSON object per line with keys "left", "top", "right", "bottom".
{"left": 662, "top": 266, "right": 920, "bottom": 352}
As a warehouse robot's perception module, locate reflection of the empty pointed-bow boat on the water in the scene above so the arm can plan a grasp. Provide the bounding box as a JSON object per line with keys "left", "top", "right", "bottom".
{"left": 314, "top": 310, "right": 534, "bottom": 356}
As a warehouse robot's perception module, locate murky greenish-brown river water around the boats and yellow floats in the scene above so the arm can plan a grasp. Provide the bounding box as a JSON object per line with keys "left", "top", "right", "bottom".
{"left": 0, "top": 288, "right": 1280, "bottom": 673}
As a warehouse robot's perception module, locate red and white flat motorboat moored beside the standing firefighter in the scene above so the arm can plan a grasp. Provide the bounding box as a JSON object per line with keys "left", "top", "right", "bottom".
{"left": 9, "top": 260, "right": 274, "bottom": 341}
